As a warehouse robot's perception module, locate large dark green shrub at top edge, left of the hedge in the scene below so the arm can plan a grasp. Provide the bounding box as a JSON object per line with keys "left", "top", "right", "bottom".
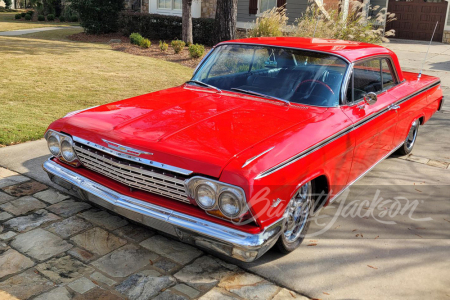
{"left": 70, "top": 0, "right": 124, "bottom": 34}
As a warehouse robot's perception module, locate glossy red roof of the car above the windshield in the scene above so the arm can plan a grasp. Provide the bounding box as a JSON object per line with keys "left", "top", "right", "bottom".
{"left": 223, "top": 37, "right": 392, "bottom": 62}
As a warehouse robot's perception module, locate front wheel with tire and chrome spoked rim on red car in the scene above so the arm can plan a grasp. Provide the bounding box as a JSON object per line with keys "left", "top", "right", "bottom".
{"left": 277, "top": 181, "right": 314, "bottom": 253}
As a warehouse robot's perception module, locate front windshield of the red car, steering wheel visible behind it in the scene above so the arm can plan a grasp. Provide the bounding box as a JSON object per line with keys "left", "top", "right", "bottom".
{"left": 192, "top": 44, "right": 348, "bottom": 107}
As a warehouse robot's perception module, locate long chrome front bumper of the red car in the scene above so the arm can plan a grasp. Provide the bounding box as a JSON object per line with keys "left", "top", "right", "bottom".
{"left": 43, "top": 159, "right": 284, "bottom": 262}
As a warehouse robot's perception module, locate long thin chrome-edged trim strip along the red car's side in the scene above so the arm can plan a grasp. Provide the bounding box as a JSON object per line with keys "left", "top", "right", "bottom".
{"left": 255, "top": 80, "right": 441, "bottom": 179}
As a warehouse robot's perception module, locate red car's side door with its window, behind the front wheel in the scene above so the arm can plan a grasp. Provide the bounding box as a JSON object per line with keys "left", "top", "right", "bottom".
{"left": 342, "top": 58, "right": 397, "bottom": 183}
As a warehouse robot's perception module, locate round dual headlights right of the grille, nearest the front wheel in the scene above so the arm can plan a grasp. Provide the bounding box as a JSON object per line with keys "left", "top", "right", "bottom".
{"left": 187, "top": 177, "right": 248, "bottom": 219}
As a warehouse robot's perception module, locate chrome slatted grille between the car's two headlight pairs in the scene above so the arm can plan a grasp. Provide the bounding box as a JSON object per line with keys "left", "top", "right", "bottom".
{"left": 74, "top": 143, "right": 189, "bottom": 203}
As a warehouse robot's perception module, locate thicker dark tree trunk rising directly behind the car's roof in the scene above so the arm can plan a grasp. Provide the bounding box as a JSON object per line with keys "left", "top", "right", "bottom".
{"left": 215, "top": 0, "right": 238, "bottom": 43}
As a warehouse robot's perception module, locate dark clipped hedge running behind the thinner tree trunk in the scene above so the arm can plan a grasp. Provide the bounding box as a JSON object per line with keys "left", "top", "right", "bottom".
{"left": 119, "top": 11, "right": 215, "bottom": 46}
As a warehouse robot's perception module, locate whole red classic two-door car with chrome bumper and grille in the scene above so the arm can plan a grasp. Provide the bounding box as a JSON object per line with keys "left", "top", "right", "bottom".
{"left": 44, "top": 38, "right": 443, "bottom": 261}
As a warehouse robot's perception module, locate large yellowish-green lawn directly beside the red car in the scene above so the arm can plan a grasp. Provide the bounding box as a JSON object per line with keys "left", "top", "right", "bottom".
{"left": 0, "top": 29, "right": 193, "bottom": 147}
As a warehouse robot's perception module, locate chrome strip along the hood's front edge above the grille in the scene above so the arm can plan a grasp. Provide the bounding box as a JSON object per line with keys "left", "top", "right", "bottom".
{"left": 72, "top": 136, "right": 193, "bottom": 175}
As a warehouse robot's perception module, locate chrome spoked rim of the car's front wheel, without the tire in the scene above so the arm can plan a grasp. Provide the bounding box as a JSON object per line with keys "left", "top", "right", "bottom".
{"left": 284, "top": 182, "right": 313, "bottom": 243}
